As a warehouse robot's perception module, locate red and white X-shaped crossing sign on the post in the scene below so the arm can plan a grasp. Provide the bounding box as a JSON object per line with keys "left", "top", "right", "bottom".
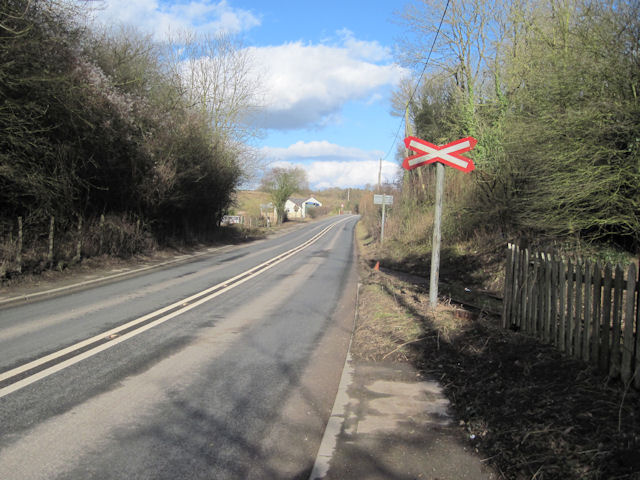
{"left": 402, "top": 137, "right": 478, "bottom": 172}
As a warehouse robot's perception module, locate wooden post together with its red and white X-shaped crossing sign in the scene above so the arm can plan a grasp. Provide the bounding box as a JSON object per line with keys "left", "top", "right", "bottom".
{"left": 402, "top": 137, "right": 478, "bottom": 309}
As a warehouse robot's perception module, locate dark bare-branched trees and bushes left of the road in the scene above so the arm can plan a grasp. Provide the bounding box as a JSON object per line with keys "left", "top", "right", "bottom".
{"left": 0, "top": 0, "right": 243, "bottom": 248}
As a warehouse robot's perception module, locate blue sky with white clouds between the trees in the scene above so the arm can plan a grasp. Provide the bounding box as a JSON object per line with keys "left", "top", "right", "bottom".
{"left": 87, "top": 0, "right": 408, "bottom": 190}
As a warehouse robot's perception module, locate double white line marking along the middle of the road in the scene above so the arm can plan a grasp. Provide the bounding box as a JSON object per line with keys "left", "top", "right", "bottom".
{"left": 0, "top": 219, "right": 347, "bottom": 398}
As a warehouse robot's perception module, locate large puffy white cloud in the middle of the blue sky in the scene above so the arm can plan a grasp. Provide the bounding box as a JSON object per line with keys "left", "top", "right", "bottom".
{"left": 249, "top": 38, "right": 406, "bottom": 130}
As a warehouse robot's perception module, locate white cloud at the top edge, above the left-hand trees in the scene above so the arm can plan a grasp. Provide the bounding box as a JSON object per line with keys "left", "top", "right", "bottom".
{"left": 87, "top": 0, "right": 260, "bottom": 40}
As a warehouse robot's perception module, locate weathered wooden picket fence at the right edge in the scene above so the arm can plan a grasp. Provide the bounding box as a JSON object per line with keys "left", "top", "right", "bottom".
{"left": 502, "top": 244, "right": 640, "bottom": 389}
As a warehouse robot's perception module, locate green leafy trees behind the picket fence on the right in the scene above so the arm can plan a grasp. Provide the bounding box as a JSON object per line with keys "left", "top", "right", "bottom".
{"left": 395, "top": 0, "right": 640, "bottom": 250}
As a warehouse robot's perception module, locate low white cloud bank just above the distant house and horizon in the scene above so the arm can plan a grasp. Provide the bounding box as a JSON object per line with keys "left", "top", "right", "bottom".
{"left": 261, "top": 141, "right": 399, "bottom": 190}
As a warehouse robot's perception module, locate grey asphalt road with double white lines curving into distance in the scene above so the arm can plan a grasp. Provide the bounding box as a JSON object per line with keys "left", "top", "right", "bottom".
{"left": 0, "top": 216, "right": 357, "bottom": 480}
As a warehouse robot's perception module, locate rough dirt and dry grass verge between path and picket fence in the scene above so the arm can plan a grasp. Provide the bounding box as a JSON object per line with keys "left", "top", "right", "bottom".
{"left": 353, "top": 229, "right": 640, "bottom": 480}
